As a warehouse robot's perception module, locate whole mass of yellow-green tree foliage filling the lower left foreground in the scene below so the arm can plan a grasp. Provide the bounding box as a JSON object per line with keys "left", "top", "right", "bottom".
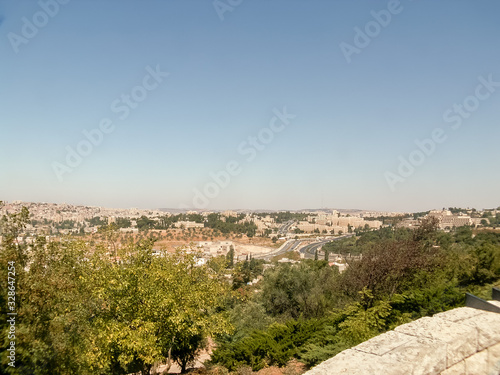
{"left": 0, "top": 204, "right": 230, "bottom": 375}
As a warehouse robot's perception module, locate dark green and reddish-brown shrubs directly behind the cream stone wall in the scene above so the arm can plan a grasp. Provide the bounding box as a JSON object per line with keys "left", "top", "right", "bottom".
{"left": 212, "top": 221, "right": 500, "bottom": 371}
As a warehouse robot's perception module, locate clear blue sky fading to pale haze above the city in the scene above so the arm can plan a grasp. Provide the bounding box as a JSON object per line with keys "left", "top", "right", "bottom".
{"left": 0, "top": 0, "right": 500, "bottom": 211}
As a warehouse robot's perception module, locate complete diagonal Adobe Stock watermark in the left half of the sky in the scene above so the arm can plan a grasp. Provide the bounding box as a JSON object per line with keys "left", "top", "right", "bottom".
{"left": 51, "top": 65, "right": 170, "bottom": 182}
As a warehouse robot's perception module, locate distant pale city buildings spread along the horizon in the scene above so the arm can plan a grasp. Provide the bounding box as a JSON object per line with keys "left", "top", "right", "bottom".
{"left": 0, "top": 201, "right": 496, "bottom": 245}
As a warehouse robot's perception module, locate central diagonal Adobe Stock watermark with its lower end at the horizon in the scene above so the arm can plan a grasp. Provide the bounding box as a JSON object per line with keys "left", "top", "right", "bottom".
{"left": 185, "top": 107, "right": 297, "bottom": 209}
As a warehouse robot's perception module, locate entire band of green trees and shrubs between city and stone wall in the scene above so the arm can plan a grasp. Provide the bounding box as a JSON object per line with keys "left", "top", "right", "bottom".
{"left": 0, "top": 206, "right": 500, "bottom": 375}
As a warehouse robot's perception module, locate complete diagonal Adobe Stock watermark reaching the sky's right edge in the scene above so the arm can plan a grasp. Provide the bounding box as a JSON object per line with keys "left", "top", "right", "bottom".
{"left": 384, "top": 74, "right": 500, "bottom": 192}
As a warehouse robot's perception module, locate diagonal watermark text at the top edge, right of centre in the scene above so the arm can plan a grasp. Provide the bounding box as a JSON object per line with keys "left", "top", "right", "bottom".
{"left": 339, "top": 0, "right": 403, "bottom": 64}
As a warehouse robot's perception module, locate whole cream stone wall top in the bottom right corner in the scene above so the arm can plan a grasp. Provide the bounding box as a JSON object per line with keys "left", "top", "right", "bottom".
{"left": 306, "top": 301, "right": 500, "bottom": 375}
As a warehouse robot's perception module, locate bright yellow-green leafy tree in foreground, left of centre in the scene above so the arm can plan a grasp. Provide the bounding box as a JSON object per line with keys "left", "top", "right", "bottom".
{"left": 88, "top": 247, "right": 230, "bottom": 374}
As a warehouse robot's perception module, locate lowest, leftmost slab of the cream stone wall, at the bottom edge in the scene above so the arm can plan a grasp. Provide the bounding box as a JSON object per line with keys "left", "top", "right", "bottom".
{"left": 306, "top": 349, "right": 412, "bottom": 375}
